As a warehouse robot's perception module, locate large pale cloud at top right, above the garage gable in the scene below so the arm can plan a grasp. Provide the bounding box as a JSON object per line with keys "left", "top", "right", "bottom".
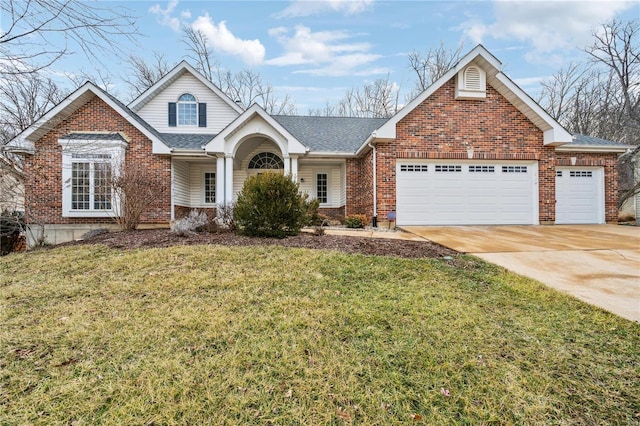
{"left": 459, "top": 0, "right": 637, "bottom": 62}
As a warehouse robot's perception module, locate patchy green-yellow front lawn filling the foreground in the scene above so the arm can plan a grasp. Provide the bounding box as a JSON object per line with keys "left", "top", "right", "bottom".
{"left": 0, "top": 245, "right": 640, "bottom": 425}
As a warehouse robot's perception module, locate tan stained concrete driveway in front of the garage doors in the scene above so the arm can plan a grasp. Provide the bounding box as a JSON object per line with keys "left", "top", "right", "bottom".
{"left": 403, "top": 225, "right": 640, "bottom": 321}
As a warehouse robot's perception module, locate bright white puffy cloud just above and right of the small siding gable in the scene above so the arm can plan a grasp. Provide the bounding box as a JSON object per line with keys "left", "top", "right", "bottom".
{"left": 191, "top": 13, "right": 265, "bottom": 65}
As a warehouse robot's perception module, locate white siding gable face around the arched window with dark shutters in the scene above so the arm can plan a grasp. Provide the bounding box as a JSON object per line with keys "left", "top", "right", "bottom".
{"left": 138, "top": 73, "right": 238, "bottom": 134}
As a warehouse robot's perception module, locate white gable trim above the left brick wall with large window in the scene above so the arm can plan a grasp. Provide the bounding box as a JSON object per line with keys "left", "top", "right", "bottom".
{"left": 6, "top": 81, "right": 171, "bottom": 154}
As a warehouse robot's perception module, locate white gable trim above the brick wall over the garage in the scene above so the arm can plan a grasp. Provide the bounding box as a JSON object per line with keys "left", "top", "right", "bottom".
{"left": 368, "top": 45, "right": 571, "bottom": 151}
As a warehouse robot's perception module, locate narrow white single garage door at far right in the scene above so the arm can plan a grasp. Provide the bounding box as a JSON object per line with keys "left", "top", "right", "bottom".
{"left": 556, "top": 167, "right": 604, "bottom": 224}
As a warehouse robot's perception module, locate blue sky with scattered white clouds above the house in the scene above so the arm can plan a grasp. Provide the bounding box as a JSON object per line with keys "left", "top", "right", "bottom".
{"left": 48, "top": 0, "right": 640, "bottom": 114}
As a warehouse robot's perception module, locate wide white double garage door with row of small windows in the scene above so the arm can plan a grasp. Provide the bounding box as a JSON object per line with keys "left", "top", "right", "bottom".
{"left": 396, "top": 160, "right": 538, "bottom": 225}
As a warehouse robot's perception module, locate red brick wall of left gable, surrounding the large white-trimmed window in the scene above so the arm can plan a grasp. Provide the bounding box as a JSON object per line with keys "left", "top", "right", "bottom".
{"left": 25, "top": 96, "right": 171, "bottom": 224}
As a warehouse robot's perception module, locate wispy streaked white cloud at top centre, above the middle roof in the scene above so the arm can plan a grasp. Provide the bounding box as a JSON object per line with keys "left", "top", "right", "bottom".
{"left": 266, "top": 25, "right": 388, "bottom": 76}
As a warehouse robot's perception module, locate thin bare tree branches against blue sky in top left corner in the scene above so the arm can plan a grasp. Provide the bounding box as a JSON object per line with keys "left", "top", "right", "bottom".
{"left": 0, "top": 0, "right": 138, "bottom": 76}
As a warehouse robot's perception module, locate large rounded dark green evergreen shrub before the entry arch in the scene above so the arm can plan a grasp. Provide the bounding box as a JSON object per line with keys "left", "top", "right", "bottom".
{"left": 234, "top": 172, "right": 319, "bottom": 238}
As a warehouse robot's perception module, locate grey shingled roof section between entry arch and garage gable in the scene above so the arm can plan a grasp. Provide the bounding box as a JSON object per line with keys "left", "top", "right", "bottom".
{"left": 273, "top": 115, "right": 388, "bottom": 154}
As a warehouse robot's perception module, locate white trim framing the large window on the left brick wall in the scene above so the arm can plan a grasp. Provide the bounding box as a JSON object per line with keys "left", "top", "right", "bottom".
{"left": 58, "top": 139, "right": 127, "bottom": 218}
